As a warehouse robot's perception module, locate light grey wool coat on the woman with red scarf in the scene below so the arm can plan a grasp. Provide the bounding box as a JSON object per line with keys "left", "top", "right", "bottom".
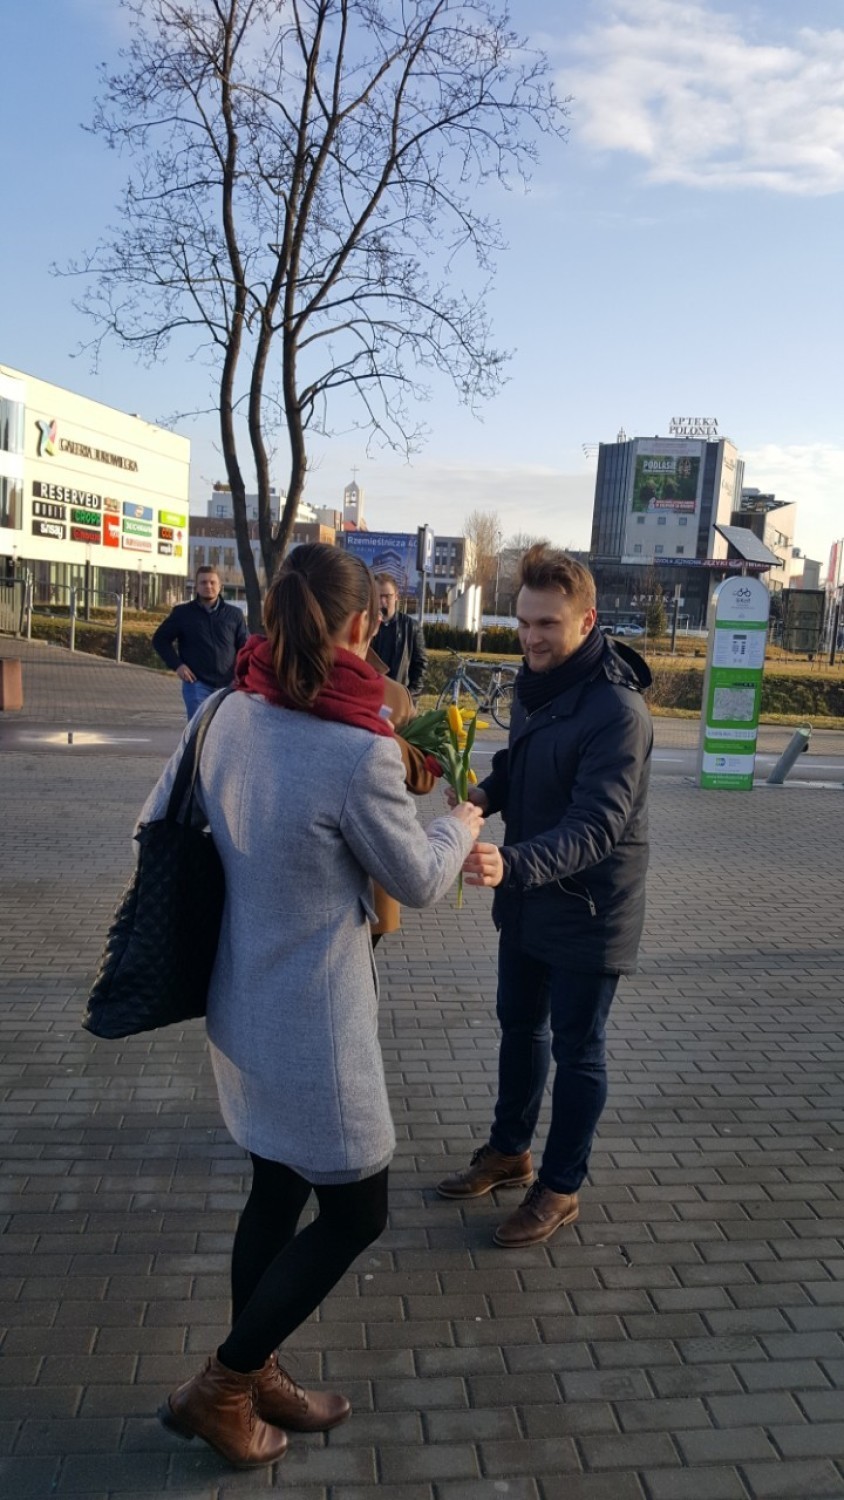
{"left": 139, "top": 693, "right": 472, "bottom": 1182}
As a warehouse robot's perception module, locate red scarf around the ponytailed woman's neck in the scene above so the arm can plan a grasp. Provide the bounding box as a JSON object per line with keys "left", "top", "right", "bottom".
{"left": 234, "top": 636, "right": 393, "bottom": 735}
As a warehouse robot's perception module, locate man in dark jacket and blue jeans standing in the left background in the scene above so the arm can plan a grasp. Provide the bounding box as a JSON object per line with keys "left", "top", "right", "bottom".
{"left": 153, "top": 567, "right": 249, "bottom": 719}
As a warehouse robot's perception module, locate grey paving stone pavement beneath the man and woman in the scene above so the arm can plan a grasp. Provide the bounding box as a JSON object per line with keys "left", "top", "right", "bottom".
{"left": 0, "top": 639, "right": 844, "bottom": 1500}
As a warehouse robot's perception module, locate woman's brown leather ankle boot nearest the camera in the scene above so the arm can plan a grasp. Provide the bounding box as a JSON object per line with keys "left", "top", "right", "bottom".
{"left": 159, "top": 1358, "right": 288, "bottom": 1469}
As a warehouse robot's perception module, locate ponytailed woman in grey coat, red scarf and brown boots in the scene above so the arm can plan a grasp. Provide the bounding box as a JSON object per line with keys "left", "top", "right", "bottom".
{"left": 141, "top": 545, "right": 481, "bottom": 1467}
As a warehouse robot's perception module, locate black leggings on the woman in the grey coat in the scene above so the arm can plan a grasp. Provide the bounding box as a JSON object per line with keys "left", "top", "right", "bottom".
{"left": 217, "top": 1157, "right": 387, "bottom": 1374}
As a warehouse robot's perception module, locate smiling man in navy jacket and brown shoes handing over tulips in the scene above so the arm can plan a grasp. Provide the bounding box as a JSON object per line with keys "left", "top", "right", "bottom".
{"left": 438, "top": 545, "right": 652, "bottom": 1248}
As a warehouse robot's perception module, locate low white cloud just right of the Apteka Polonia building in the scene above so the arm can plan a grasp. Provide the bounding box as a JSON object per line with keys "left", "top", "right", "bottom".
{"left": 742, "top": 443, "right": 844, "bottom": 567}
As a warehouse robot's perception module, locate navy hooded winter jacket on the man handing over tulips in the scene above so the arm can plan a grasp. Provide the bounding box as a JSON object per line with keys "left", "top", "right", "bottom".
{"left": 481, "top": 641, "right": 654, "bottom": 974}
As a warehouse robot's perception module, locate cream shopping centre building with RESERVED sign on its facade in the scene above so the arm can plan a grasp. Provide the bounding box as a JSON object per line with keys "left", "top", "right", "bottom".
{"left": 0, "top": 365, "right": 190, "bottom": 605}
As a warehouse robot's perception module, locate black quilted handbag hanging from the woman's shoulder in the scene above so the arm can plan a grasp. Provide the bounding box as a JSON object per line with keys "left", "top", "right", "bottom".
{"left": 82, "top": 689, "right": 234, "bottom": 1038}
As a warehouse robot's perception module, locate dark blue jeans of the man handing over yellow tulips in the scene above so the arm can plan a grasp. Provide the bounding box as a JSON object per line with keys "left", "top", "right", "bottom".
{"left": 490, "top": 938, "right": 618, "bottom": 1193}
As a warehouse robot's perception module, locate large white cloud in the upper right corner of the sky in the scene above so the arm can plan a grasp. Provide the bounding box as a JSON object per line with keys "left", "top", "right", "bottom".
{"left": 561, "top": 0, "right": 844, "bottom": 195}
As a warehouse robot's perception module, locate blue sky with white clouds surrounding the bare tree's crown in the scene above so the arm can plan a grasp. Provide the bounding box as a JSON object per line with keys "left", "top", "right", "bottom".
{"left": 0, "top": 0, "right": 844, "bottom": 561}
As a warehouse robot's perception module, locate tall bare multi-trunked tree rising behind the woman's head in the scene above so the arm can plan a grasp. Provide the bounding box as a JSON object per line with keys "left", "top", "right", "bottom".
{"left": 67, "top": 0, "right": 567, "bottom": 624}
